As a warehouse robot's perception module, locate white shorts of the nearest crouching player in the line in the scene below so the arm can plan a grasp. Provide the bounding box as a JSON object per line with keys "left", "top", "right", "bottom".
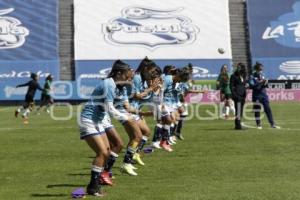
{"left": 79, "top": 117, "right": 105, "bottom": 139}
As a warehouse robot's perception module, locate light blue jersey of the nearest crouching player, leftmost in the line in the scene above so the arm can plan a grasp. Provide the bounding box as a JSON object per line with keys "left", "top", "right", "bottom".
{"left": 81, "top": 78, "right": 116, "bottom": 122}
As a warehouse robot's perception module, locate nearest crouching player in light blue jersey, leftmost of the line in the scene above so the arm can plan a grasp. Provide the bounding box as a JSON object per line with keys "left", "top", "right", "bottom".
{"left": 79, "top": 60, "right": 131, "bottom": 196}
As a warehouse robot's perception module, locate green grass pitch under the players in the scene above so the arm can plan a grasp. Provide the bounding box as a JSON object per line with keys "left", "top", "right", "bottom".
{"left": 0, "top": 103, "right": 300, "bottom": 200}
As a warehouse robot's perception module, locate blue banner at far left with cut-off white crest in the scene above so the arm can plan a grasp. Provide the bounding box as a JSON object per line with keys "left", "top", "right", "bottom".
{"left": 0, "top": 0, "right": 59, "bottom": 100}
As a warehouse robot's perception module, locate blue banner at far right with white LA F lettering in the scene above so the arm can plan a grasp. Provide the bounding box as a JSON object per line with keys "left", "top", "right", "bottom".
{"left": 247, "top": 0, "right": 300, "bottom": 80}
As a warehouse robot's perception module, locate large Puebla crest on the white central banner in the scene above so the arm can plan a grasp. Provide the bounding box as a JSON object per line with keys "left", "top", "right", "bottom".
{"left": 102, "top": 6, "right": 199, "bottom": 49}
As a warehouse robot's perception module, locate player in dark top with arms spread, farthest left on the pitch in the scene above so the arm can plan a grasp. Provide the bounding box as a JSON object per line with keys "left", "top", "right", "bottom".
{"left": 15, "top": 73, "right": 43, "bottom": 124}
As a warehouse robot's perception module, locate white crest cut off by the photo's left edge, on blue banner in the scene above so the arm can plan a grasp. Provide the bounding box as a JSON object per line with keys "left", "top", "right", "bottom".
{"left": 0, "top": 8, "right": 29, "bottom": 49}
